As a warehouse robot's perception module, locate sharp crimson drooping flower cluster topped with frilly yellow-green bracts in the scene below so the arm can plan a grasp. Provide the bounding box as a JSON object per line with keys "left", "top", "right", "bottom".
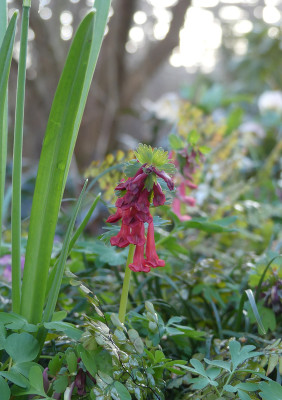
{"left": 106, "top": 145, "right": 174, "bottom": 272}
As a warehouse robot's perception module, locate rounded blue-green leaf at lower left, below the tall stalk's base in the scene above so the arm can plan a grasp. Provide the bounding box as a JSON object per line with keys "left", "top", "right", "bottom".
{"left": 5, "top": 332, "right": 39, "bottom": 363}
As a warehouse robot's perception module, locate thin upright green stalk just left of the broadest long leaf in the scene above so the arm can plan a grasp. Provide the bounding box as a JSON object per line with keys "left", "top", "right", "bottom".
{"left": 12, "top": 2, "right": 30, "bottom": 313}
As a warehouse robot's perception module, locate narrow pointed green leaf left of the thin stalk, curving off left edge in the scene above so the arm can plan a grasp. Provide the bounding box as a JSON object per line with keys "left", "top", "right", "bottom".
{"left": 0, "top": 11, "right": 18, "bottom": 247}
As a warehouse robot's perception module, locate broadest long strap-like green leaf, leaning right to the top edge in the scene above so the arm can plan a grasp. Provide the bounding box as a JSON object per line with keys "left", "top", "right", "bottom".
{"left": 21, "top": 0, "right": 109, "bottom": 323}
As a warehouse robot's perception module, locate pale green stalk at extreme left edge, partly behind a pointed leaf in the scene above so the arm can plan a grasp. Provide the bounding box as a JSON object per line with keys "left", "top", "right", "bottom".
{"left": 0, "top": 0, "right": 8, "bottom": 249}
